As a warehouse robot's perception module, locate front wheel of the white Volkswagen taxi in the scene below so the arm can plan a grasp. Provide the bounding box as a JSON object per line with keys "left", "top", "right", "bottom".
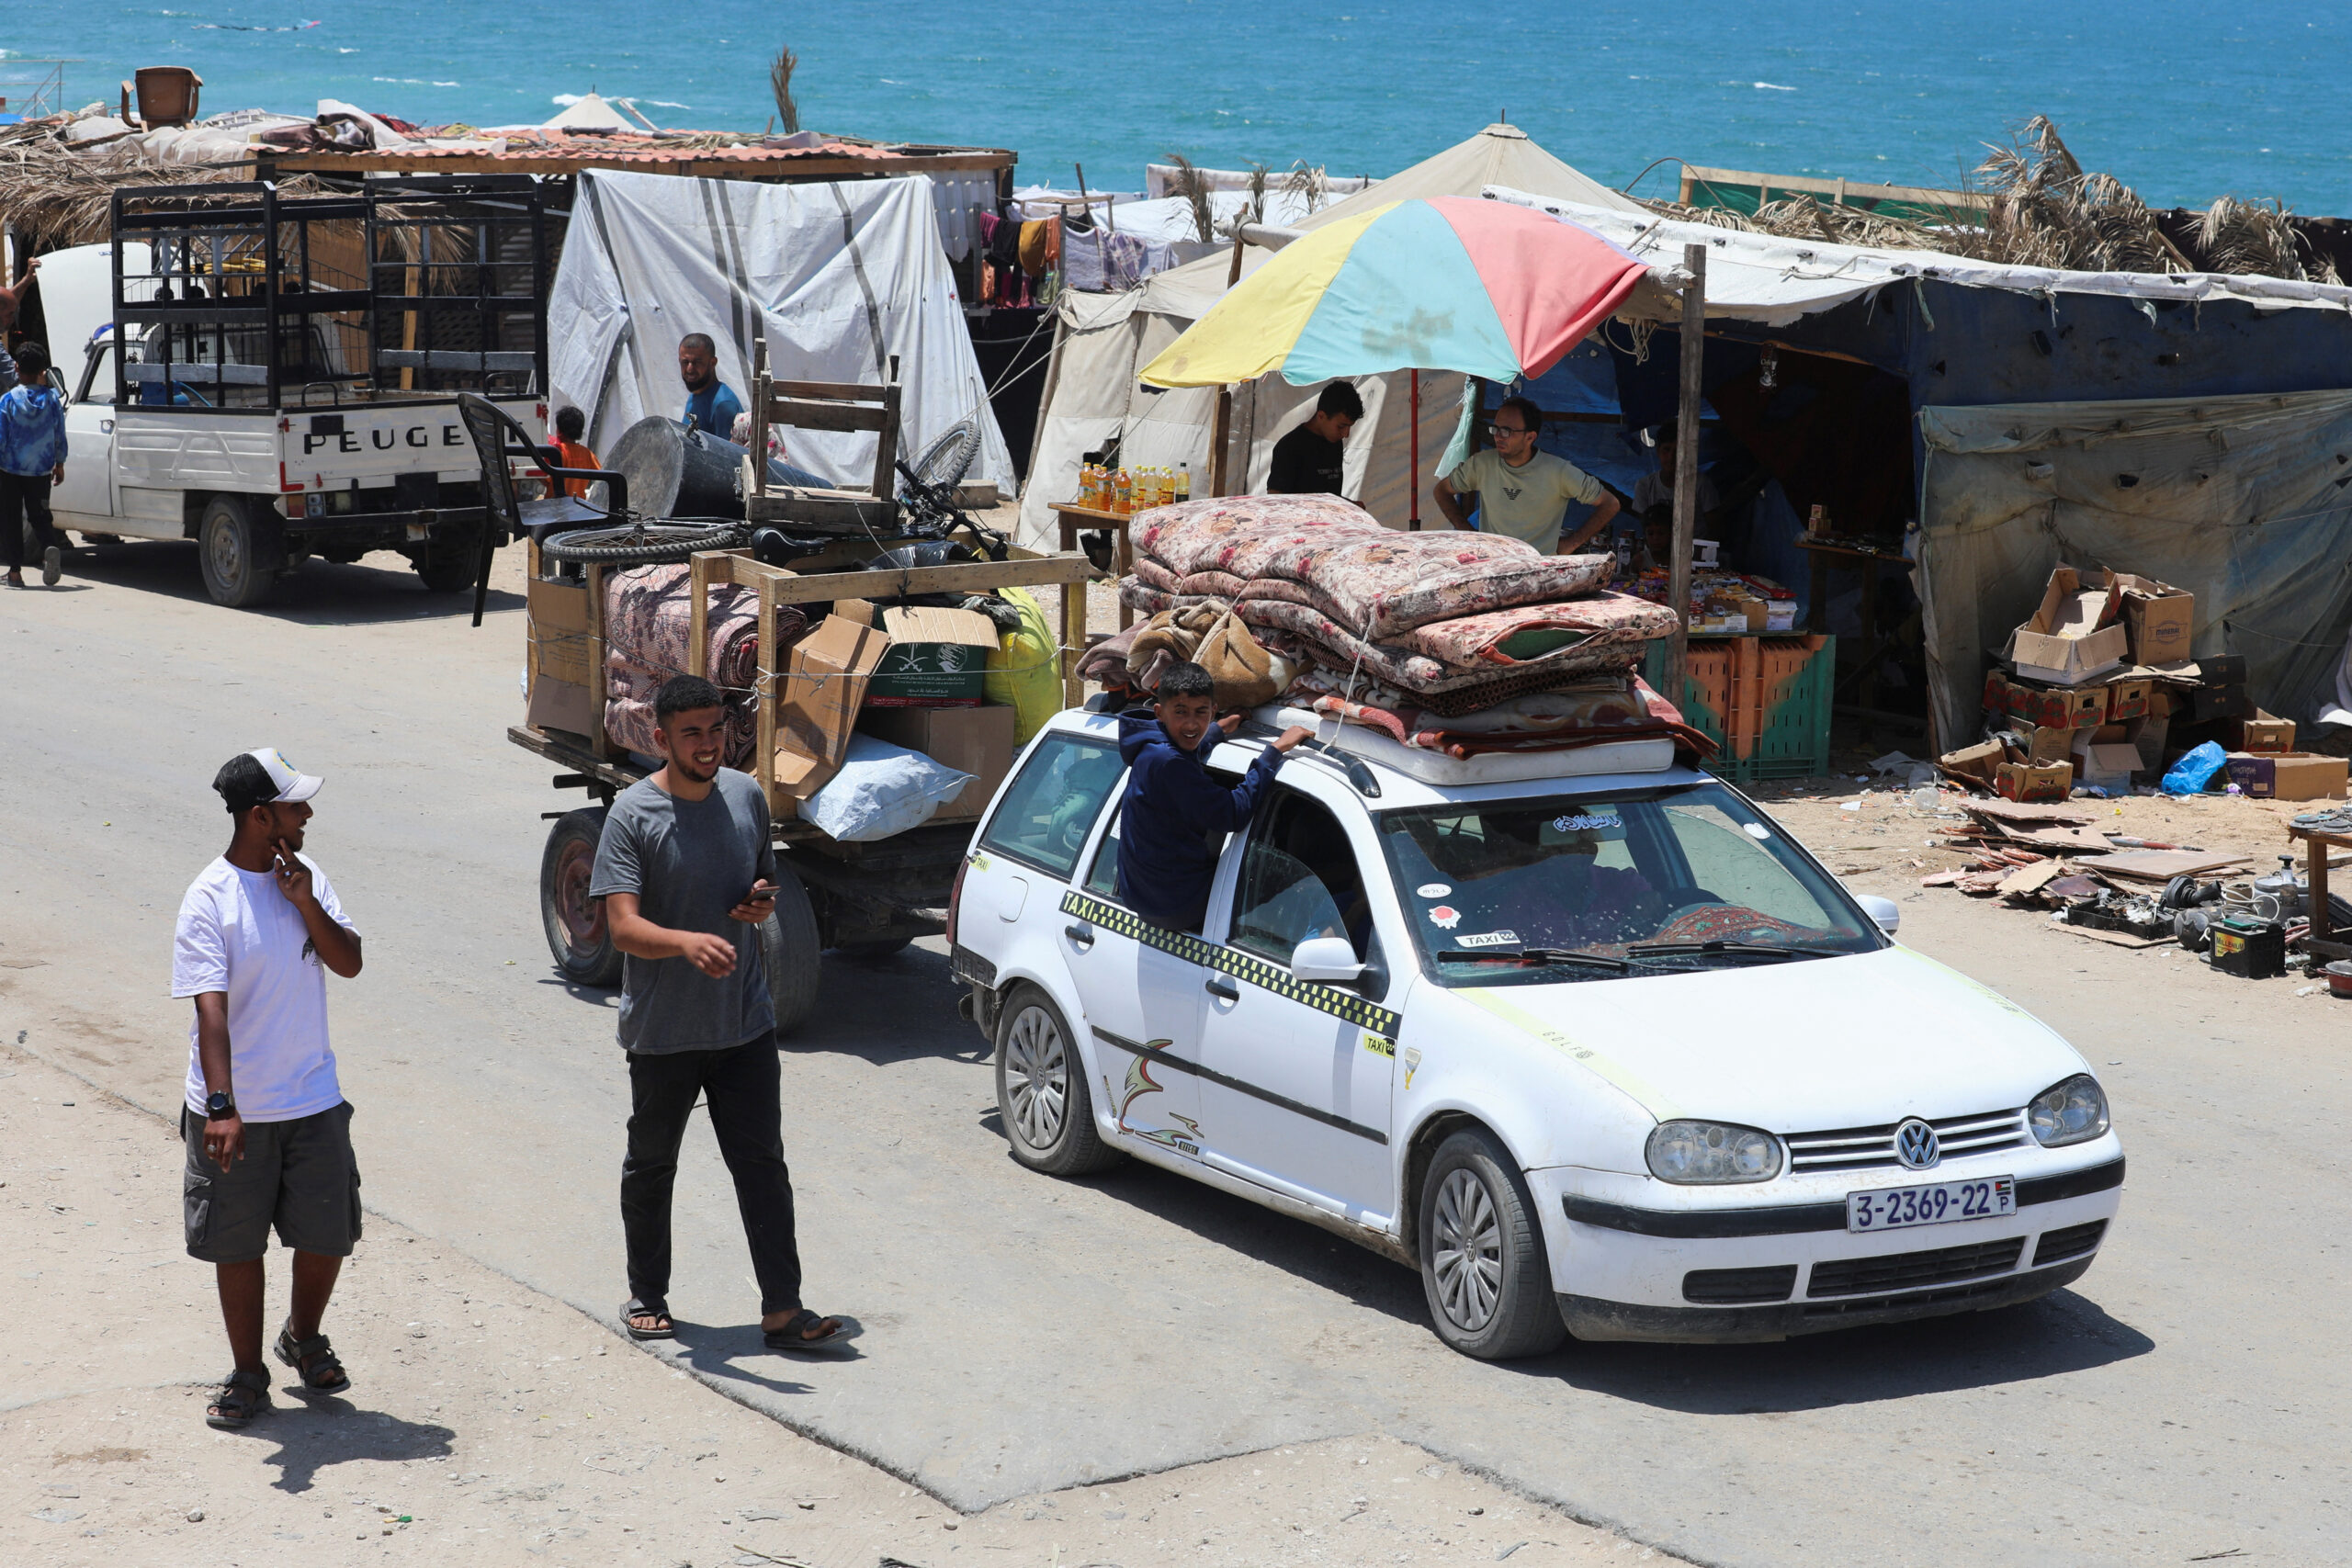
{"left": 1420, "top": 1126, "right": 1569, "bottom": 1361}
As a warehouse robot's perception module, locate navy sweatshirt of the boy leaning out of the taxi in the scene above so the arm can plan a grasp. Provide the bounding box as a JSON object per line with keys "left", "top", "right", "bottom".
{"left": 1120, "top": 712, "right": 1282, "bottom": 931}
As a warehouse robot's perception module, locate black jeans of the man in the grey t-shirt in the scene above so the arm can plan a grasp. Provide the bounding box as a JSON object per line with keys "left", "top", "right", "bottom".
{"left": 621, "top": 1034, "right": 799, "bottom": 1316}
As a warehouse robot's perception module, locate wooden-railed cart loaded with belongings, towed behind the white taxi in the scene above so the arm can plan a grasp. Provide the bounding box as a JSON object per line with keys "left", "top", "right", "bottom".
{"left": 505, "top": 546, "right": 1101, "bottom": 1032}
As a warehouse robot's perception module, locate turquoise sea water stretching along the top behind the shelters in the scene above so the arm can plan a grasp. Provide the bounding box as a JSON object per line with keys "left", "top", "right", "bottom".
{"left": 18, "top": 0, "right": 2352, "bottom": 214}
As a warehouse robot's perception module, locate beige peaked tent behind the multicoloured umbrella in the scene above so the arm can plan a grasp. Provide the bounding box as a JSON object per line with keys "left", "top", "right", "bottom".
{"left": 1021, "top": 125, "right": 1646, "bottom": 546}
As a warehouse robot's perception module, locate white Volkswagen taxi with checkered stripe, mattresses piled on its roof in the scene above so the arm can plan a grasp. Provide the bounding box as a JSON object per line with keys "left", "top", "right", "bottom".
{"left": 948, "top": 710, "right": 2124, "bottom": 1359}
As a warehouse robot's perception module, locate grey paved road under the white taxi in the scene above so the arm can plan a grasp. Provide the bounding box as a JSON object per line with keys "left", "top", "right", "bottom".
{"left": 0, "top": 546, "right": 2352, "bottom": 1563}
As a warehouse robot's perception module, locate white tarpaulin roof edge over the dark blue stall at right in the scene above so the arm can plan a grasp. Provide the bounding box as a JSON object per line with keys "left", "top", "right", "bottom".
{"left": 1484, "top": 184, "right": 2352, "bottom": 327}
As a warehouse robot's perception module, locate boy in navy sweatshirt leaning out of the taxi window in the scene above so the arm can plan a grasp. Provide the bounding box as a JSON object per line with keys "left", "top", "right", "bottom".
{"left": 1120, "top": 663, "right": 1307, "bottom": 931}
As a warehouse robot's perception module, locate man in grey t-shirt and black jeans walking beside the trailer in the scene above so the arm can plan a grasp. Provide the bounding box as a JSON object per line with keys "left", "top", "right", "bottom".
{"left": 588, "top": 674, "right": 844, "bottom": 1349}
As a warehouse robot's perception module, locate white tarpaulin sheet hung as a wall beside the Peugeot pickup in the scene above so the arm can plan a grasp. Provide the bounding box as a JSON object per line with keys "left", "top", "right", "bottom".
{"left": 548, "top": 172, "right": 1013, "bottom": 493}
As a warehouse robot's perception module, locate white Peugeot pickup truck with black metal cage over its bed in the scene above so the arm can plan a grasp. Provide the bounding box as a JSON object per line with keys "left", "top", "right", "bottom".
{"left": 40, "top": 176, "right": 548, "bottom": 604}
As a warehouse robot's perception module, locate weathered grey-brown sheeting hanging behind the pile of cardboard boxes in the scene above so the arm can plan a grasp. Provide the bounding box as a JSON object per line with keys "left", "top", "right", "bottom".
{"left": 1919, "top": 392, "right": 2352, "bottom": 745}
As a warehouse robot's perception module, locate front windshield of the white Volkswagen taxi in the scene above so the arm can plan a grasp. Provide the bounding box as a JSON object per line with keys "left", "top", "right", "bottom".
{"left": 1378, "top": 783, "right": 1882, "bottom": 985}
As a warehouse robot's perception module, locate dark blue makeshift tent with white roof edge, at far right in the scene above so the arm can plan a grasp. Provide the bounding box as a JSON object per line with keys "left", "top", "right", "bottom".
{"left": 1487, "top": 188, "right": 2352, "bottom": 740}
